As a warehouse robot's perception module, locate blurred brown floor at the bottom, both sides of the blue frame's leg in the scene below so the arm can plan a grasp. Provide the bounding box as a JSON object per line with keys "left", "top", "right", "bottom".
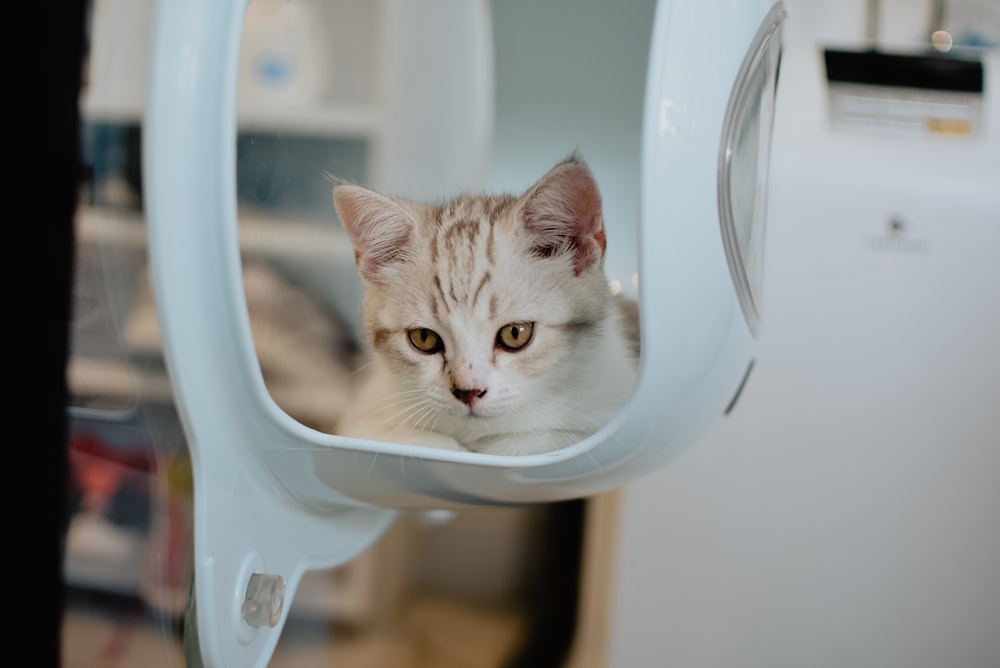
{"left": 62, "top": 597, "right": 522, "bottom": 668}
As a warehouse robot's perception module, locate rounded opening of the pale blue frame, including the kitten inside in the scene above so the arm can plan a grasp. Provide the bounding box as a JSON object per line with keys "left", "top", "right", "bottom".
{"left": 236, "top": 0, "right": 655, "bottom": 455}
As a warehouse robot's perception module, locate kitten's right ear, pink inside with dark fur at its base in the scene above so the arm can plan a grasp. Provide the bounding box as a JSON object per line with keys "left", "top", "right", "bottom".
{"left": 521, "top": 156, "right": 607, "bottom": 275}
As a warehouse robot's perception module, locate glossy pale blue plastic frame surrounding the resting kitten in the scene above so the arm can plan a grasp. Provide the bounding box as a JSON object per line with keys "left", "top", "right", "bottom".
{"left": 143, "top": 0, "right": 784, "bottom": 667}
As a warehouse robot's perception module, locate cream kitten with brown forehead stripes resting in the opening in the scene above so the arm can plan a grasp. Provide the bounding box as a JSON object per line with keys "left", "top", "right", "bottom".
{"left": 333, "top": 156, "right": 636, "bottom": 455}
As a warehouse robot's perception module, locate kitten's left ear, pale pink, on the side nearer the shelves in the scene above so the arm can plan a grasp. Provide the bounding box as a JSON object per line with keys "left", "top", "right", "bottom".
{"left": 333, "top": 182, "right": 416, "bottom": 281}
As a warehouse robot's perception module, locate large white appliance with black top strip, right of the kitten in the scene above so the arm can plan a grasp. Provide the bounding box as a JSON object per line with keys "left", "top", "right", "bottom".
{"left": 608, "top": 42, "right": 1000, "bottom": 668}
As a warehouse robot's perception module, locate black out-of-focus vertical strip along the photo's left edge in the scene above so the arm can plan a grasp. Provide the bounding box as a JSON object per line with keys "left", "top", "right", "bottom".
{"left": 28, "top": 0, "right": 87, "bottom": 666}
